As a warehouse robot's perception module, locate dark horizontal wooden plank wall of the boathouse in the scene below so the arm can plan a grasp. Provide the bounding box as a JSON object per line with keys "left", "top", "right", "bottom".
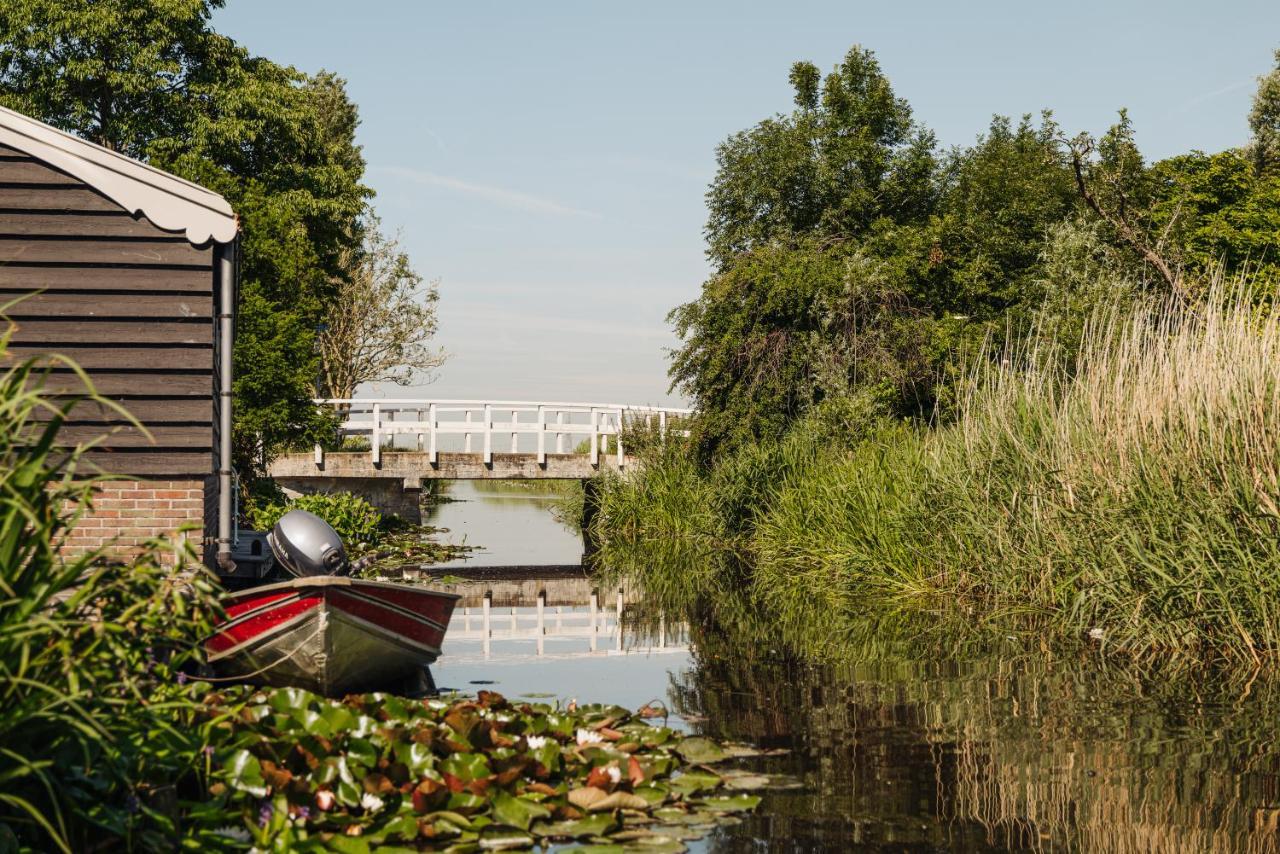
{"left": 0, "top": 146, "right": 214, "bottom": 478}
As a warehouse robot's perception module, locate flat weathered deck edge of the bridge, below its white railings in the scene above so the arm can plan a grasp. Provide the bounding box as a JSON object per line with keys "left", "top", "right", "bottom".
{"left": 270, "top": 449, "right": 634, "bottom": 489}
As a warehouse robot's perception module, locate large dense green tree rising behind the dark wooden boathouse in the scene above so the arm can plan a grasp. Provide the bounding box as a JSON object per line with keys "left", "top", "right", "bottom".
{"left": 0, "top": 0, "right": 371, "bottom": 472}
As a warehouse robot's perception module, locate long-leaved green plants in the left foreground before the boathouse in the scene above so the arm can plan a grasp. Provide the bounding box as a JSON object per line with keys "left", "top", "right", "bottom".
{"left": 0, "top": 334, "right": 218, "bottom": 851}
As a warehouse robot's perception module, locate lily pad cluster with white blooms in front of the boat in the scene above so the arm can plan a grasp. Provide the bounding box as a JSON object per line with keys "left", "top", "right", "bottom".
{"left": 192, "top": 689, "right": 776, "bottom": 854}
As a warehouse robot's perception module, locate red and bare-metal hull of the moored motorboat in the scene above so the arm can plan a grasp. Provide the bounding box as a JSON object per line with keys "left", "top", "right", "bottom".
{"left": 205, "top": 576, "right": 458, "bottom": 695}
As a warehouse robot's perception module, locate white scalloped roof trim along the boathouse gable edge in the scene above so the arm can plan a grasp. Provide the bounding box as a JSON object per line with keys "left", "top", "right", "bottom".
{"left": 0, "top": 106, "right": 237, "bottom": 246}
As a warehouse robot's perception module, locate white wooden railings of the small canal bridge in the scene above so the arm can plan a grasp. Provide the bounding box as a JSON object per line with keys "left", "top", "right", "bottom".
{"left": 315, "top": 398, "right": 691, "bottom": 466}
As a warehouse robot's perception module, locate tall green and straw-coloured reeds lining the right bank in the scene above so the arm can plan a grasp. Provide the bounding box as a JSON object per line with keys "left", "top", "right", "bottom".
{"left": 595, "top": 286, "right": 1280, "bottom": 663}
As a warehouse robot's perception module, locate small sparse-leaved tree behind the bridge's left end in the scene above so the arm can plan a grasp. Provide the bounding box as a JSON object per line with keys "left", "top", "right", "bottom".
{"left": 319, "top": 216, "right": 445, "bottom": 399}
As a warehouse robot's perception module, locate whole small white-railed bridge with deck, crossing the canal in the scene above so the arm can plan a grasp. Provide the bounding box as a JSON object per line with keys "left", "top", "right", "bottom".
{"left": 270, "top": 398, "right": 690, "bottom": 489}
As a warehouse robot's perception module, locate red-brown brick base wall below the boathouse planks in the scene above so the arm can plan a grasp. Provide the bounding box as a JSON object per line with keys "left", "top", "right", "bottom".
{"left": 67, "top": 480, "right": 205, "bottom": 560}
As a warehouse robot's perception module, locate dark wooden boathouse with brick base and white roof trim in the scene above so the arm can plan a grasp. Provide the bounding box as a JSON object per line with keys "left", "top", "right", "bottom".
{"left": 0, "top": 108, "right": 238, "bottom": 568}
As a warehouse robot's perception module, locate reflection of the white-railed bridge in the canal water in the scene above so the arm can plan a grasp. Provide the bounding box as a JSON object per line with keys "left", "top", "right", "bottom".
{"left": 444, "top": 575, "right": 689, "bottom": 663}
